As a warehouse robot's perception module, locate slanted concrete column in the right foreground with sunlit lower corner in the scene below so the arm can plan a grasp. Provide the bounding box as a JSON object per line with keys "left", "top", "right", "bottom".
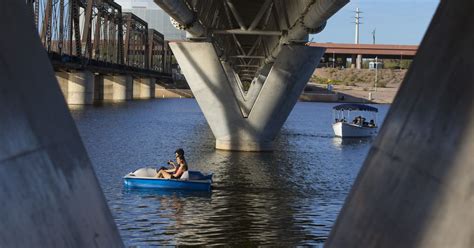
{"left": 326, "top": 1, "right": 474, "bottom": 248}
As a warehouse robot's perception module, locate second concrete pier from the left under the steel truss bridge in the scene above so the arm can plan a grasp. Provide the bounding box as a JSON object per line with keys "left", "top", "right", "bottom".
{"left": 104, "top": 75, "right": 133, "bottom": 101}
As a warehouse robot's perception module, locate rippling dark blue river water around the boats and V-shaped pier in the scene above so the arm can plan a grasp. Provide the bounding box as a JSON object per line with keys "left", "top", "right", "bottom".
{"left": 71, "top": 99, "right": 389, "bottom": 246}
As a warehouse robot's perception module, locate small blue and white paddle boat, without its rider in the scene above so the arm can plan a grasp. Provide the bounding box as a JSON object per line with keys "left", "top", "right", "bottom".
{"left": 123, "top": 167, "right": 212, "bottom": 191}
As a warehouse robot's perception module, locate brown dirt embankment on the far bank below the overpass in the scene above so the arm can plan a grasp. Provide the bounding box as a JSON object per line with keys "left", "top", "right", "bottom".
{"left": 305, "top": 68, "right": 407, "bottom": 103}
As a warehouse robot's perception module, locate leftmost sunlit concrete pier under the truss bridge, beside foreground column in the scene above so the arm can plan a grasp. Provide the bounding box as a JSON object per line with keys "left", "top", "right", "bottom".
{"left": 56, "top": 71, "right": 94, "bottom": 105}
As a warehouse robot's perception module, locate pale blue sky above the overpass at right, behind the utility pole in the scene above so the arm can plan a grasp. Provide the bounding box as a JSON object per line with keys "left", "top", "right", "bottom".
{"left": 310, "top": 0, "right": 439, "bottom": 45}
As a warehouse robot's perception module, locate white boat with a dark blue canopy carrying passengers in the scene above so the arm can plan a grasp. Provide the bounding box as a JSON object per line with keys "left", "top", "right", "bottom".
{"left": 332, "top": 104, "right": 378, "bottom": 138}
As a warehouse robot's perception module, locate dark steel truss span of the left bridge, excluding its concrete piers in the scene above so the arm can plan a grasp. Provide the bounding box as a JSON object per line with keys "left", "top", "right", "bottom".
{"left": 27, "top": 0, "right": 172, "bottom": 78}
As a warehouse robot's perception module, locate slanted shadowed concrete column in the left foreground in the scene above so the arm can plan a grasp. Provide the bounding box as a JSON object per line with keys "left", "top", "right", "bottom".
{"left": 0, "top": 0, "right": 123, "bottom": 247}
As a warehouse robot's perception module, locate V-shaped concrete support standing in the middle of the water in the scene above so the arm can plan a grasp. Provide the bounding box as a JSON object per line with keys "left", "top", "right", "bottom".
{"left": 170, "top": 42, "right": 324, "bottom": 151}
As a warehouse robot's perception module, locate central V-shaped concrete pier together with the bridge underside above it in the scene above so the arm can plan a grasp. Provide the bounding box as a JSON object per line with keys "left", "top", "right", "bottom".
{"left": 155, "top": 0, "right": 348, "bottom": 151}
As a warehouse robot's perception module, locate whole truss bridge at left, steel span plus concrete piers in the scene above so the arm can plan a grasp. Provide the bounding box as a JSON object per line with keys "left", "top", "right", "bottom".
{"left": 27, "top": 0, "right": 172, "bottom": 104}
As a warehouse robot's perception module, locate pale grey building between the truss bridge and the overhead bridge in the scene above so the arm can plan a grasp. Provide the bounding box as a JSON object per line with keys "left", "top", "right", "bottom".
{"left": 115, "top": 0, "right": 186, "bottom": 40}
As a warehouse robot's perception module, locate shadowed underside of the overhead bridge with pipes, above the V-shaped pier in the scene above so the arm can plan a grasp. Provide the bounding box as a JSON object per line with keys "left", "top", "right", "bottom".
{"left": 155, "top": 0, "right": 349, "bottom": 83}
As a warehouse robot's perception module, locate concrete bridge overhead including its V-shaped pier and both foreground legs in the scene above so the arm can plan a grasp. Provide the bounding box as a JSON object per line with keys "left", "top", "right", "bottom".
{"left": 0, "top": 0, "right": 474, "bottom": 248}
